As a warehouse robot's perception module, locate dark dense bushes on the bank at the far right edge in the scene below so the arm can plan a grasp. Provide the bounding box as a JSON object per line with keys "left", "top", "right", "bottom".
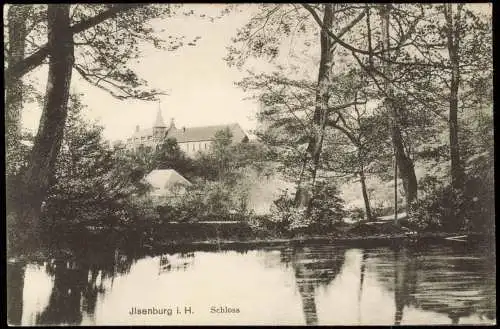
{"left": 412, "top": 106, "right": 495, "bottom": 234}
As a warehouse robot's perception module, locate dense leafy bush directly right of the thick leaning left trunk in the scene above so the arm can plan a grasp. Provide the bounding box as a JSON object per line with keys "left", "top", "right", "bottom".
{"left": 42, "top": 96, "right": 148, "bottom": 231}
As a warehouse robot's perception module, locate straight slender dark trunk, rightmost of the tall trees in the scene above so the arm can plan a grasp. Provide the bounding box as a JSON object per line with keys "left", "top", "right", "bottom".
{"left": 444, "top": 3, "right": 464, "bottom": 191}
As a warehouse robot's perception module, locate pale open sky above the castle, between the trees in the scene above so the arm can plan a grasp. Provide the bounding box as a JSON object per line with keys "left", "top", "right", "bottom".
{"left": 22, "top": 5, "right": 257, "bottom": 141}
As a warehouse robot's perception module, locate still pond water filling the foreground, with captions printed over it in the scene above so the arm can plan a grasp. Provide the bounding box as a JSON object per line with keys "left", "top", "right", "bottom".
{"left": 8, "top": 240, "right": 496, "bottom": 325}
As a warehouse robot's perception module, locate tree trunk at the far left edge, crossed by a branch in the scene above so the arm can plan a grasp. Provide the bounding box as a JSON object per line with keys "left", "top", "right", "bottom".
{"left": 5, "top": 5, "right": 31, "bottom": 150}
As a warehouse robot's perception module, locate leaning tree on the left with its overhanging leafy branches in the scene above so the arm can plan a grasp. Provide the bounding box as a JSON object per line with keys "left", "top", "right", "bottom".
{"left": 4, "top": 4, "right": 222, "bottom": 249}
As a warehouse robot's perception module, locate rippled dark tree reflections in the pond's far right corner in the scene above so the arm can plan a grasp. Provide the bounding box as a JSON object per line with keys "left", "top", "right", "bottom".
{"left": 369, "top": 246, "right": 496, "bottom": 325}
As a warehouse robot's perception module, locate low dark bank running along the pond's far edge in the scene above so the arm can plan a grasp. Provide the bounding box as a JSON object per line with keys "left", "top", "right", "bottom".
{"left": 8, "top": 211, "right": 494, "bottom": 260}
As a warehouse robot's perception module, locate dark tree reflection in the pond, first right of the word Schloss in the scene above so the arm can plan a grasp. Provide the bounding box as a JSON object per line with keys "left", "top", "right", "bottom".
{"left": 281, "top": 245, "right": 345, "bottom": 325}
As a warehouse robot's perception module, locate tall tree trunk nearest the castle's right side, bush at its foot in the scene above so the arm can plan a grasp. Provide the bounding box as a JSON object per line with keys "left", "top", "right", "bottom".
{"left": 295, "top": 4, "right": 333, "bottom": 215}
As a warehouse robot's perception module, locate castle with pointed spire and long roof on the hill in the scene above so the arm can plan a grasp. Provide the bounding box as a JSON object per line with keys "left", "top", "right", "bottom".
{"left": 126, "top": 108, "right": 248, "bottom": 157}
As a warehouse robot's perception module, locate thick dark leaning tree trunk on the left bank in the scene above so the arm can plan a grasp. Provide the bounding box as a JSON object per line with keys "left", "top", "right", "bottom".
{"left": 12, "top": 4, "right": 74, "bottom": 247}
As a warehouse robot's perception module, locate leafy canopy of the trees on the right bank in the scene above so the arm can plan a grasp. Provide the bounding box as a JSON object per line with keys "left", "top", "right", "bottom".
{"left": 226, "top": 4, "right": 492, "bottom": 231}
